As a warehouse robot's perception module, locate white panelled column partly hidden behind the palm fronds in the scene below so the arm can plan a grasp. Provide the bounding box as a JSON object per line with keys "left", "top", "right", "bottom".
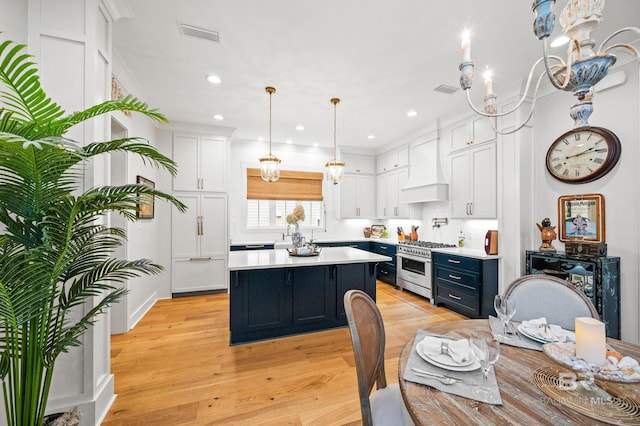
{"left": 17, "top": 0, "right": 115, "bottom": 426}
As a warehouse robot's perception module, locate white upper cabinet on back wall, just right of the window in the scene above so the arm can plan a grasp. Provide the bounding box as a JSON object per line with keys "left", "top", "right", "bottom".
{"left": 340, "top": 173, "right": 376, "bottom": 218}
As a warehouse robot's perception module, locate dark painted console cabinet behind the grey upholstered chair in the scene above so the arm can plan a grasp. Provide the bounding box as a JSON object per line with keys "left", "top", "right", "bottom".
{"left": 526, "top": 250, "right": 620, "bottom": 339}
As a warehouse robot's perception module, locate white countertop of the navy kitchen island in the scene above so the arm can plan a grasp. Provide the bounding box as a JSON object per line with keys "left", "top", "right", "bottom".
{"left": 228, "top": 247, "right": 392, "bottom": 271}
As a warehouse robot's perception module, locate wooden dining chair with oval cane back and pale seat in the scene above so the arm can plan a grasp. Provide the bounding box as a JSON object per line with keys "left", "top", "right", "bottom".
{"left": 344, "top": 290, "right": 414, "bottom": 426}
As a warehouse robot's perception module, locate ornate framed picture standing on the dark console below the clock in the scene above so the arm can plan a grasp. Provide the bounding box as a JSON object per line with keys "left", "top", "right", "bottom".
{"left": 558, "top": 194, "right": 605, "bottom": 243}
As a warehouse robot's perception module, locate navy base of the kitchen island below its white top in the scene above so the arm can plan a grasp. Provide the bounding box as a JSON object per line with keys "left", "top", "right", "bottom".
{"left": 229, "top": 263, "right": 376, "bottom": 345}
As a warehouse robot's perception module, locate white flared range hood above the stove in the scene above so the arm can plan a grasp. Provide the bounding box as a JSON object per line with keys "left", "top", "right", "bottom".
{"left": 400, "top": 137, "right": 449, "bottom": 203}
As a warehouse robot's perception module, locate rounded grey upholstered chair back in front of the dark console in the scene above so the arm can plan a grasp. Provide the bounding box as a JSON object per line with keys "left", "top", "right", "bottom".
{"left": 505, "top": 274, "right": 600, "bottom": 330}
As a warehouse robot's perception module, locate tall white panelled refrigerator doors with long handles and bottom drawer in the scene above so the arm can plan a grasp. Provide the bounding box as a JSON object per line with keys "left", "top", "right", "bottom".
{"left": 171, "top": 194, "right": 228, "bottom": 293}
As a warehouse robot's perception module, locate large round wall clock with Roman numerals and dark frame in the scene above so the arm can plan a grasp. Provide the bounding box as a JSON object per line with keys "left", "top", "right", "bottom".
{"left": 547, "top": 126, "right": 622, "bottom": 183}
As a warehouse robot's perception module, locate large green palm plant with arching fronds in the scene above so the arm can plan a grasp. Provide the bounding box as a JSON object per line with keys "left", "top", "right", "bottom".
{"left": 0, "top": 41, "right": 185, "bottom": 426}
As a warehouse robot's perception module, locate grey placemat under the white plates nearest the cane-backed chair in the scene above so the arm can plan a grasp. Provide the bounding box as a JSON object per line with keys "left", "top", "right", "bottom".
{"left": 403, "top": 330, "right": 502, "bottom": 405}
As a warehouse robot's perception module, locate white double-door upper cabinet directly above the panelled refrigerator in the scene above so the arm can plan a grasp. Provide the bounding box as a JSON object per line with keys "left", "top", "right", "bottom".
{"left": 173, "top": 134, "right": 227, "bottom": 192}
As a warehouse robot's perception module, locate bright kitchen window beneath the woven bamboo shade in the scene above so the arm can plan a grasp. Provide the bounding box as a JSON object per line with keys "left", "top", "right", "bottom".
{"left": 247, "top": 200, "right": 324, "bottom": 229}
